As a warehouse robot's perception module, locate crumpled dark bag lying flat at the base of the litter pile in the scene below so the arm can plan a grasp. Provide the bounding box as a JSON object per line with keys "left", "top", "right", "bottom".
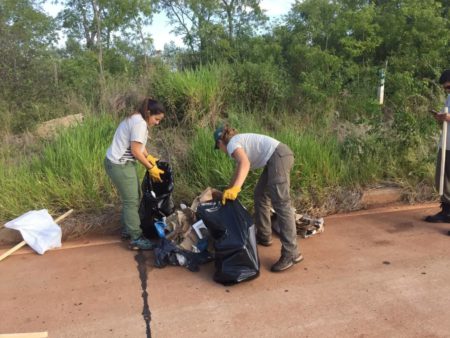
{"left": 153, "top": 238, "right": 214, "bottom": 272}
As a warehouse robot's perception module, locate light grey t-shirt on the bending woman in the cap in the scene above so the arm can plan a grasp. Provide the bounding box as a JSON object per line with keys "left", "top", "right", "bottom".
{"left": 227, "top": 134, "right": 280, "bottom": 169}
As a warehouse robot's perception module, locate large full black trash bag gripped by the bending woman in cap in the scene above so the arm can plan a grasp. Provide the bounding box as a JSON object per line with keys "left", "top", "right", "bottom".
{"left": 197, "top": 200, "right": 259, "bottom": 285}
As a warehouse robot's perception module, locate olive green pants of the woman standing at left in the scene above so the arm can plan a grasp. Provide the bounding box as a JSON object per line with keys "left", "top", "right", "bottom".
{"left": 104, "top": 158, "right": 142, "bottom": 240}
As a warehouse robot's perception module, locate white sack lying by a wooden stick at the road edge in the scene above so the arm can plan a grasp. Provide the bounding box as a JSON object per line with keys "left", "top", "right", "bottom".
{"left": 5, "top": 209, "right": 61, "bottom": 255}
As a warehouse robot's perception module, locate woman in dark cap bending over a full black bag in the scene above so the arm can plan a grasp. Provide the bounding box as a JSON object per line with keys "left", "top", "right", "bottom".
{"left": 214, "top": 127, "right": 303, "bottom": 272}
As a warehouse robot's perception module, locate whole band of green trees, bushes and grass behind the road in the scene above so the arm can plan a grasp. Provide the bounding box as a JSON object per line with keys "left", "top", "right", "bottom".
{"left": 0, "top": 0, "right": 450, "bottom": 221}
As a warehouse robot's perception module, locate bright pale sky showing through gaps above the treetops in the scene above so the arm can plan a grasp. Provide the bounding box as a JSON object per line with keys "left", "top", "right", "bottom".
{"left": 43, "top": 0, "right": 295, "bottom": 50}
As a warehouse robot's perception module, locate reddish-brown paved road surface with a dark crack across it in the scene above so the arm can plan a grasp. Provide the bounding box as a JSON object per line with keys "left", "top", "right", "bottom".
{"left": 0, "top": 205, "right": 450, "bottom": 338}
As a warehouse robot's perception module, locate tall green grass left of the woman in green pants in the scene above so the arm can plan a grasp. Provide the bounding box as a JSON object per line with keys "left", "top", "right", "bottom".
{"left": 0, "top": 115, "right": 117, "bottom": 220}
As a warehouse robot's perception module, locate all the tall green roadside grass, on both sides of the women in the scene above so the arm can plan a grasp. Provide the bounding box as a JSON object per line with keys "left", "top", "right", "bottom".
{"left": 0, "top": 65, "right": 439, "bottom": 221}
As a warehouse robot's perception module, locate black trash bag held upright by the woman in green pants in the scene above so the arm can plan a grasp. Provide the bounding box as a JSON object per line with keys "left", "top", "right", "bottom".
{"left": 139, "top": 161, "right": 174, "bottom": 238}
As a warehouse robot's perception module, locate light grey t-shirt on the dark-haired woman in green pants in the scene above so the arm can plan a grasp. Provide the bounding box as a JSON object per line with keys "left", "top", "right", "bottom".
{"left": 106, "top": 114, "right": 148, "bottom": 164}
